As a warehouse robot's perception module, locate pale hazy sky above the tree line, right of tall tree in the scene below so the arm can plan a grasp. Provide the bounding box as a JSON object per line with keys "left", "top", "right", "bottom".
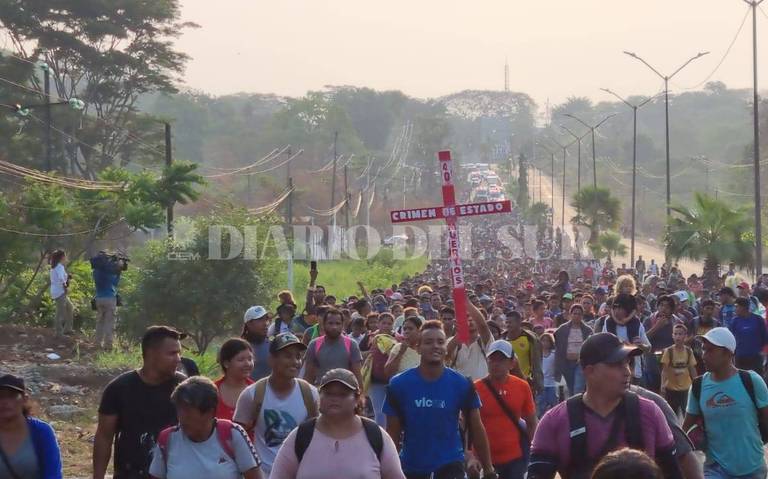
{"left": 178, "top": 0, "right": 768, "bottom": 106}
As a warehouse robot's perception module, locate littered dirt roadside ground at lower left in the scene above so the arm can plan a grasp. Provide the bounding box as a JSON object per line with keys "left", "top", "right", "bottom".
{"left": 0, "top": 326, "right": 120, "bottom": 479}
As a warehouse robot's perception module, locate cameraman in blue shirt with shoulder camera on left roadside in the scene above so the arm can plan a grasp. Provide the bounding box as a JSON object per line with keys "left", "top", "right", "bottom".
{"left": 91, "top": 251, "right": 128, "bottom": 349}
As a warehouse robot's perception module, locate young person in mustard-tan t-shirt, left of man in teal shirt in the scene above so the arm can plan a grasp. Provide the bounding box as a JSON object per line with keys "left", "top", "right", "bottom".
{"left": 661, "top": 323, "right": 696, "bottom": 415}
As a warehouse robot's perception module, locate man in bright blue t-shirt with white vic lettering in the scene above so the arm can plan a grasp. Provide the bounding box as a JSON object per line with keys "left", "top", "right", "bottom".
{"left": 384, "top": 320, "right": 495, "bottom": 479}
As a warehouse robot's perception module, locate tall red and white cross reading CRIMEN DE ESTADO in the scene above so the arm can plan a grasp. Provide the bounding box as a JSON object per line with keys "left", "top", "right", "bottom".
{"left": 390, "top": 151, "right": 512, "bottom": 344}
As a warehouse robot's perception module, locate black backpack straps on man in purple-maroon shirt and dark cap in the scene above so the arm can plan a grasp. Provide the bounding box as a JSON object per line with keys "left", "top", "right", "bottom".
{"left": 566, "top": 391, "right": 645, "bottom": 479}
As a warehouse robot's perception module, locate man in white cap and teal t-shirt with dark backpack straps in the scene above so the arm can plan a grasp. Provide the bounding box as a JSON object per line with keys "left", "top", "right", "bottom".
{"left": 683, "top": 328, "right": 768, "bottom": 479}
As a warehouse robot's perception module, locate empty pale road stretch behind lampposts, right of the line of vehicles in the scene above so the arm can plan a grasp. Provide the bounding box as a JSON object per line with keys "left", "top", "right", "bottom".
{"left": 528, "top": 168, "right": 704, "bottom": 276}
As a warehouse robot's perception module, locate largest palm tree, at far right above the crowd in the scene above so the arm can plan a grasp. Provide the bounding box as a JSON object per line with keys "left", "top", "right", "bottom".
{"left": 666, "top": 193, "right": 755, "bottom": 287}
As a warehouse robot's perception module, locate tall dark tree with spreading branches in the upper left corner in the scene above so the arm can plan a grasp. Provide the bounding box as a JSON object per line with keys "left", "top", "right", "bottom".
{"left": 0, "top": 0, "right": 196, "bottom": 178}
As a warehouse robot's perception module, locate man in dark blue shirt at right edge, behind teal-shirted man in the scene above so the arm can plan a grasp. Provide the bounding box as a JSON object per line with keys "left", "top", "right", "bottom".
{"left": 728, "top": 298, "right": 768, "bottom": 376}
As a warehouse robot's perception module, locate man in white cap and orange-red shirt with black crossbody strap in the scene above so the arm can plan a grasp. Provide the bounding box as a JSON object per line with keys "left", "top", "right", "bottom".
{"left": 475, "top": 339, "right": 537, "bottom": 479}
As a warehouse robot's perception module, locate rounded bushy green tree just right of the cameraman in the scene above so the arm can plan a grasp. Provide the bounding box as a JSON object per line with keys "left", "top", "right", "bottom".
{"left": 122, "top": 208, "right": 281, "bottom": 353}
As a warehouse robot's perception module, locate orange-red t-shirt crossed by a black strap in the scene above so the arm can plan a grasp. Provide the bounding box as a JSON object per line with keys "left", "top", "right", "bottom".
{"left": 475, "top": 375, "right": 535, "bottom": 464}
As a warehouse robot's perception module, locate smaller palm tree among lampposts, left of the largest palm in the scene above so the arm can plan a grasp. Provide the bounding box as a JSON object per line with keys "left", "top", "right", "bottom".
{"left": 571, "top": 186, "right": 621, "bottom": 245}
